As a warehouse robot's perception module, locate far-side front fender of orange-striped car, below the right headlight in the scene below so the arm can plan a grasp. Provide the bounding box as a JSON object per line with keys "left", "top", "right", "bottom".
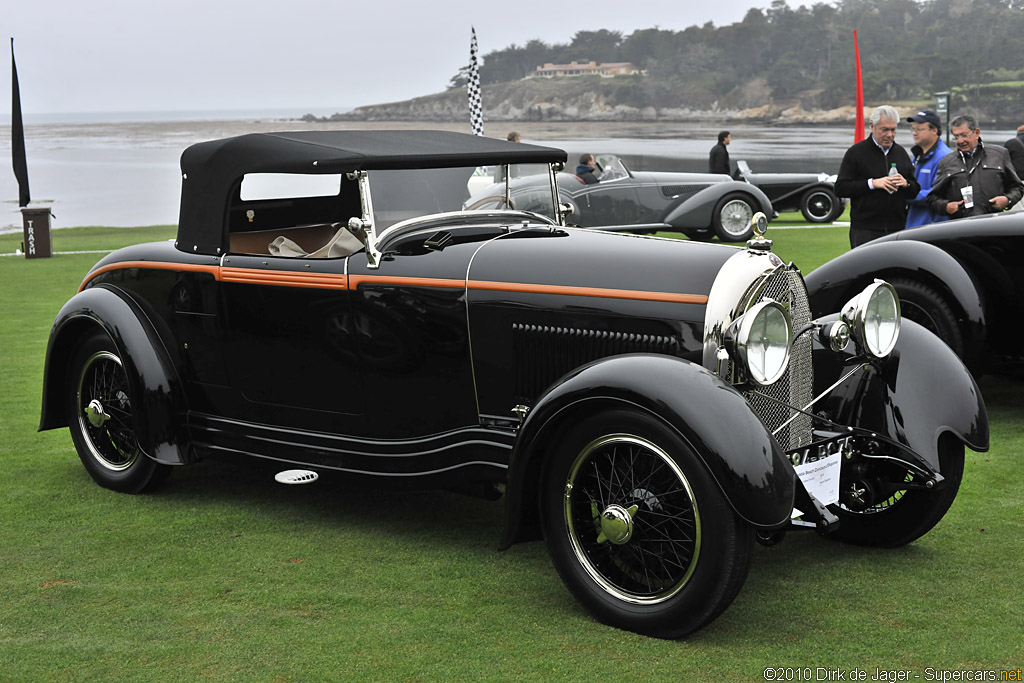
{"left": 814, "top": 315, "right": 988, "bottom": 471}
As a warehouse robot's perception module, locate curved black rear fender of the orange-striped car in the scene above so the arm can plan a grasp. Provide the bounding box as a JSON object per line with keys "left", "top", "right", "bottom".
{"left": 39, "top": 285, "right": 194, "bottom": 465}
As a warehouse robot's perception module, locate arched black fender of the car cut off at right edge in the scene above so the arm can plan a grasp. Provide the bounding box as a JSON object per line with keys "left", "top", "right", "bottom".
{"left": 804, "top": 241, "right": 986, "bottom": 366}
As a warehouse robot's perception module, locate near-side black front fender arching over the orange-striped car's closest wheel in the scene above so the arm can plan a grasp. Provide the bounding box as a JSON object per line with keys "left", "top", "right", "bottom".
{"left": 502, "top": 354, "right": 796, "bottom": 548}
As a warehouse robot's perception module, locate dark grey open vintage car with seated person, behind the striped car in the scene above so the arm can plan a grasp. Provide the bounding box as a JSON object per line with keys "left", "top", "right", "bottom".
{"left": 466, "top": 155, "right": 772, "bottom": 242}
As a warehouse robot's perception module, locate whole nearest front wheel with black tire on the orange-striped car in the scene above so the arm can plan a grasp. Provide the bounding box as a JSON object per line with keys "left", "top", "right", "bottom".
{"left": 541, "top": 410, "right": 754, "bottom": 638}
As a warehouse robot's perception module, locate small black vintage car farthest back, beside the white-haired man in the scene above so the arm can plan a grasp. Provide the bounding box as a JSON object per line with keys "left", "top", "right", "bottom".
{"left": 736, "top": 161, "right": 846, "bottom": 223}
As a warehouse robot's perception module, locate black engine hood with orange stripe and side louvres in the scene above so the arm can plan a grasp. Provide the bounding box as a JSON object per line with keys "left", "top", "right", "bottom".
{"left": 467, "top": 227, "right": 738, "bottom": 420}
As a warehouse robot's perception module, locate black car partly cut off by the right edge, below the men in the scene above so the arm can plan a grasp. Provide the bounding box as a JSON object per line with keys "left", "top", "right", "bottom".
{"left": 807, "top": 212, "right": 1024, "bottom": 374}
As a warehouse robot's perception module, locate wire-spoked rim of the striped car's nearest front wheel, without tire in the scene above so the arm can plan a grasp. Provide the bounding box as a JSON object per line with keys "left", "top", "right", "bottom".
{"left": 564, "top": 434, "right": 700, "bottom": 603}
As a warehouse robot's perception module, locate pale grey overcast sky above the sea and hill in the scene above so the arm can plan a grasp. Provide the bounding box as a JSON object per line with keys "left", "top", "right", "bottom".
{"left": 8, "top": 0, "right": 770, "bottom": 116}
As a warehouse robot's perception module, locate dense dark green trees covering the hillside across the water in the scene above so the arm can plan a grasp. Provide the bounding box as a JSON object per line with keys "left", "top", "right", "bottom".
{"left": 452, "top": 0, "right": 1024, "bottom": 108}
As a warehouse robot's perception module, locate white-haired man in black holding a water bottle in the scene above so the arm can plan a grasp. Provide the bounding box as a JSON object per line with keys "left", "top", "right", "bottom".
{"left": 836, "top": 105, "right": 921, "bottom": 248}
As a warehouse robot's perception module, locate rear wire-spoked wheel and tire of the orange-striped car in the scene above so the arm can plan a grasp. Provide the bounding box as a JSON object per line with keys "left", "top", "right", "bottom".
{"left": 66, "top": 333, "right": 171, "bottom": 494}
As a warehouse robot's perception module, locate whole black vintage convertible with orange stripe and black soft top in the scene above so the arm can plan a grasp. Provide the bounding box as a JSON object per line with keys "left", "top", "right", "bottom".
{"left": 40, "top": 131, "right": 988, "bottom": 637}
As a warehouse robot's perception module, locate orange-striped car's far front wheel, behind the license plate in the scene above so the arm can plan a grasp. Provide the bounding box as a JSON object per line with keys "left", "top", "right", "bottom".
{"left": 829, "top": 434, "right": 964, "bottom": 548}
